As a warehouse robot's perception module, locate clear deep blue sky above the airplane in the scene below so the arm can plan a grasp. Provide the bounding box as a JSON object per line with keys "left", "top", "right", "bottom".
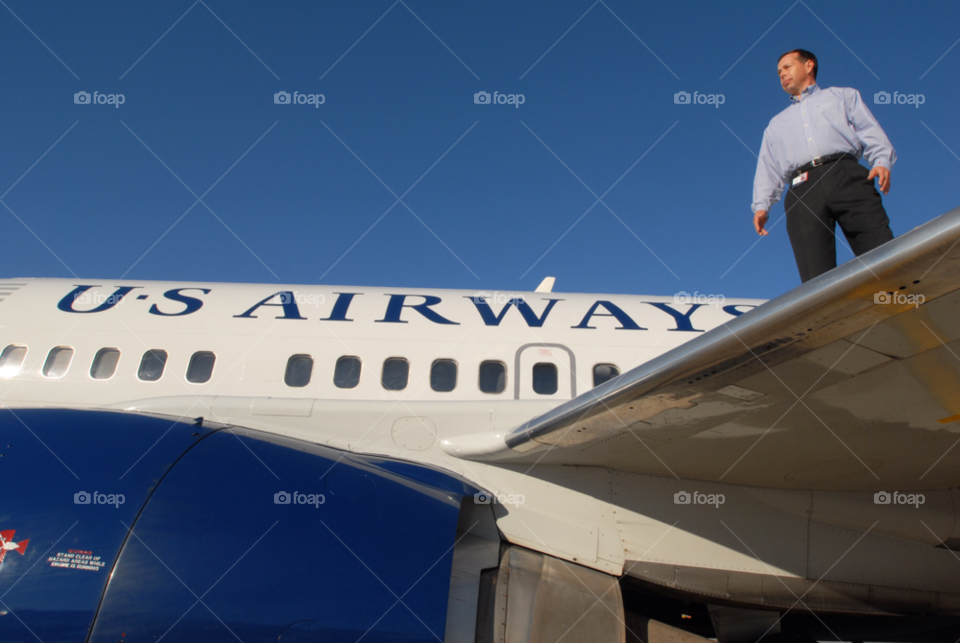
{"left": 0, "top": 0, "right": 960, "bottom": 298}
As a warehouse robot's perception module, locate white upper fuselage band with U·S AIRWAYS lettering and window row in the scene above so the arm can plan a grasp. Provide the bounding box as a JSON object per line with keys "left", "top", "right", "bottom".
{"left": 0, "top": 280, "right": 761, "bottom": 405}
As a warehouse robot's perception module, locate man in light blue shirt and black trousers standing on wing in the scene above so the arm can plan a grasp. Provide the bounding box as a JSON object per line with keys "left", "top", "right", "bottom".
{"left": 753, "top": 49, "right": 897, "bottom": 282}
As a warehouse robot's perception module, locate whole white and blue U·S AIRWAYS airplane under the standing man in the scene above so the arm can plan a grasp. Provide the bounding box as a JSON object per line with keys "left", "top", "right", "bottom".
{"left": 0, "top": 208, "right": 960, "bottom": 643}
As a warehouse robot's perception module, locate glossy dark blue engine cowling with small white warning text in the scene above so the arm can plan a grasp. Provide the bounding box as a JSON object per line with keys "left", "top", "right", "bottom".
{"left": 0, "top": 409, "right": 477, "bottom": 643}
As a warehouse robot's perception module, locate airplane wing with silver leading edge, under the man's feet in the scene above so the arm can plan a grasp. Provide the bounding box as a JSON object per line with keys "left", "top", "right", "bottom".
{"left": 445, "top": 208, "right": 960, "bottom": 491}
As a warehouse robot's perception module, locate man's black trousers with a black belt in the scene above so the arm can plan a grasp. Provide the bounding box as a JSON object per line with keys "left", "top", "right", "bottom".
{"left": 783, "top": 159, "right": 893, "bottom": 282}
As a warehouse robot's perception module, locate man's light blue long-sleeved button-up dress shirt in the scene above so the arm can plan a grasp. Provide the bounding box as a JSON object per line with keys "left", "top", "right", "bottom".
{"left": 753, "top": 84, "right": 897, "bottom": 212}
